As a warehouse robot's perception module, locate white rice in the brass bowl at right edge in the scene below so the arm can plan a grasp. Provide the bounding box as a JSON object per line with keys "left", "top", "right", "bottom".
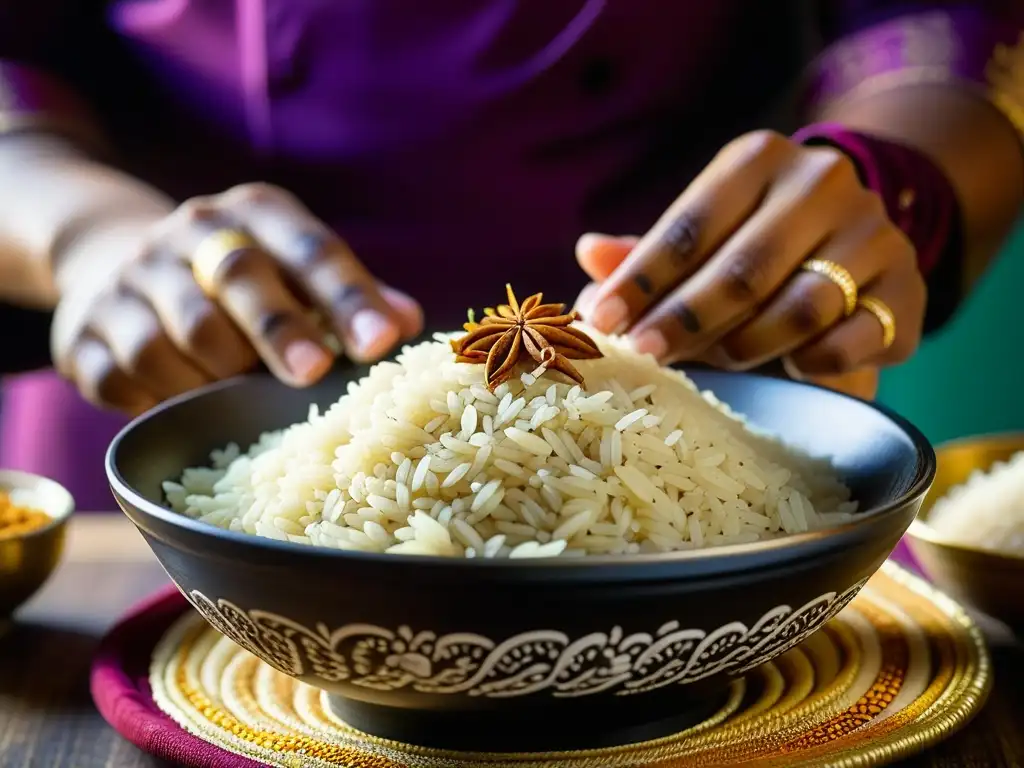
{"left": 928, "top": 452, "right": 1024, "bottom": 555}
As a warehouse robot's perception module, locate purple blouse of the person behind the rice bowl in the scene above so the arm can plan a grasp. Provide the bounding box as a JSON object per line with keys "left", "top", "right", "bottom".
{"left": 0, "top": 0, "right": 1020, "bottom": 509}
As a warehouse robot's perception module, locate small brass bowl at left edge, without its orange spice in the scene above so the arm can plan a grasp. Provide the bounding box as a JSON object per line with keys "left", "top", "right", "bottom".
{"left": 0, "top": 469, "right": 75, "bottom": 621}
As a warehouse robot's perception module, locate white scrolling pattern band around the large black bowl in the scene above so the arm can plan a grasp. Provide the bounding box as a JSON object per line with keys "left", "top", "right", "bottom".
{"left": 187, "top": 580, "right": 866, "bottom": 698}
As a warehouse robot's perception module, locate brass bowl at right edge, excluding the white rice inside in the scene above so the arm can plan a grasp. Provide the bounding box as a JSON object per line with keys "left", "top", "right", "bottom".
{"left": 906, "top": 433, "right": 1024, "bottom": 629}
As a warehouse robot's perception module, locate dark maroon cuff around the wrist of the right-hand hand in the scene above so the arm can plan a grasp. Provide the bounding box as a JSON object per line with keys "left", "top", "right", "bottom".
{"left": 793, "top": 123, "right": 963, "bottom": 331}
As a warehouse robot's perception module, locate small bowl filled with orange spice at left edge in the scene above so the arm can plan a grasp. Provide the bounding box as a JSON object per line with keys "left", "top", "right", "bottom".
{"left": 0, "top": 469, "right": 75, "bottom": 620}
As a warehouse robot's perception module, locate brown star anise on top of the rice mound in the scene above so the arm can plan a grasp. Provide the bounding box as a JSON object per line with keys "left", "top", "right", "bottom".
{"left": 452, "top": 286, "right": 603, "bottom": 391}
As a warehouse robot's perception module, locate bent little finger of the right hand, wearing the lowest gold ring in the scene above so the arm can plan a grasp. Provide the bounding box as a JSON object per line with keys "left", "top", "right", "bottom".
{"left": 786, "top": 269, "right": 927, "bottom": 378}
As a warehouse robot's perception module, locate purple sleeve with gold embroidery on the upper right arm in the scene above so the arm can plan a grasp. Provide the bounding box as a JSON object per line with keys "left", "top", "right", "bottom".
{"left": 805, "top": 0, "right": 1024, "bottom": 128}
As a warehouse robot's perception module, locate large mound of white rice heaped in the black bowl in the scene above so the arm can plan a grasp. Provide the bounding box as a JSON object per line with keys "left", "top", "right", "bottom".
{"left": 164, "top": 334, "right": 856, "bottom": 558}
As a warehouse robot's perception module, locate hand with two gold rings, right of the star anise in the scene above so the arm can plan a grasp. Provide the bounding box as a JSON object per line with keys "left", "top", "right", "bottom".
{"left": 577, "top": 132, "right": 926, "bottom": 396}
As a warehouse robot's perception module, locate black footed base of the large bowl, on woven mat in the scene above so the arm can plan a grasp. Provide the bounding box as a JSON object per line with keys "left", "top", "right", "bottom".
{"left": 330, "top": 685, "right": 729, "bottom": 753}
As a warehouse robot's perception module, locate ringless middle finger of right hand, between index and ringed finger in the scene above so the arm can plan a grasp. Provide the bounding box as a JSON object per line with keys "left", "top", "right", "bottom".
{"left": 631, "top": 155, "right": 869, "bottom": 362}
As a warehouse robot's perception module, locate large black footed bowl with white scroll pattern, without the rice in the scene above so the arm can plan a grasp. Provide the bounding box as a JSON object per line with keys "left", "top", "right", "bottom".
{"left": 106, "top": 371, "right": 935, "bottom": 751}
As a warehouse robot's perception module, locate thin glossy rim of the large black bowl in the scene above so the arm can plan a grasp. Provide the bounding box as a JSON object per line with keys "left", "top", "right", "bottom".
{"left": 103, "top": 370, "right": 937, "bottom": 570}
